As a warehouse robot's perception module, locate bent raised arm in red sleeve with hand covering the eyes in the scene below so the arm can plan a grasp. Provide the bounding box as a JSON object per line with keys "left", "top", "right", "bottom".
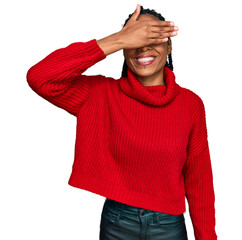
{"left": 27, "top": 3, "right": 178, "bottom": 116}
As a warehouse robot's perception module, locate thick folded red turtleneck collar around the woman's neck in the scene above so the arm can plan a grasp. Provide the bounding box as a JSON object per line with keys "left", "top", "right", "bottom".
{"left": 120, "top": 66, "right": 181, "bottom": 106}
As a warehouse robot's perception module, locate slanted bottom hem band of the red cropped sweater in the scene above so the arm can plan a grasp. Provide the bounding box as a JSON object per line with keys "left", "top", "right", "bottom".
{"left": 68, "top": 169, "right": 186, "bottom": 215}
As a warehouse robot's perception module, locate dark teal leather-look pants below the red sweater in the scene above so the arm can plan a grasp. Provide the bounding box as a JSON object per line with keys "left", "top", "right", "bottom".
{"left": 99, "top": 198, "right": 188, "bottom": 240}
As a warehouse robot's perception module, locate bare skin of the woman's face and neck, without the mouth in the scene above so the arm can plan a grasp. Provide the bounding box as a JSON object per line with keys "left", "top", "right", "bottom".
{"left": 123, "top": 14, "right": 172, "bottom": 86}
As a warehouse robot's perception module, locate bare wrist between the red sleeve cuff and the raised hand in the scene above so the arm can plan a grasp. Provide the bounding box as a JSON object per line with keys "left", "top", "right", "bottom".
{"left": 97, "top": 32, "right": 124, "bottom": 55}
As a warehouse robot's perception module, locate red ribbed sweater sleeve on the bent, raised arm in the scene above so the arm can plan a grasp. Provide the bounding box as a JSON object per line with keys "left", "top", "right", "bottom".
{"left": 27, "top": 39, "right": 106, "bottom": 116}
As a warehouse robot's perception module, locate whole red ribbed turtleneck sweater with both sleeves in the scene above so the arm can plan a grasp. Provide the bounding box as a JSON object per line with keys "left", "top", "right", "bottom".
{"left": 27, "top": 39, "right": 217, "bottom": 240}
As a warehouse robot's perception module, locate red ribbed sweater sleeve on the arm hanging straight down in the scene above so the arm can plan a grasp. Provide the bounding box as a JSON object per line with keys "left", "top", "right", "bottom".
{"left": 183, "top": 95, "right": 217, "bottom": 240}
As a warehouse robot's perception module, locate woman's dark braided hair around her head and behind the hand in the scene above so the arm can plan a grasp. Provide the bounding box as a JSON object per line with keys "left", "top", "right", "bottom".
{"left": 122, "top": 5, "right": 173, "bottom": 77}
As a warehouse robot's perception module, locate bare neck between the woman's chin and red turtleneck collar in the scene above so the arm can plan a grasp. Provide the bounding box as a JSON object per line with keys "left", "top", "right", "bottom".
{"left": 136, "top": 68, "right": 166, "bottom": 86}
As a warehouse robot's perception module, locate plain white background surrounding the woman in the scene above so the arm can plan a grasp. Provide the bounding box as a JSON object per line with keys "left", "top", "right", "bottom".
{"left": 0, "top": 0, "right": 242, "bottom": 240}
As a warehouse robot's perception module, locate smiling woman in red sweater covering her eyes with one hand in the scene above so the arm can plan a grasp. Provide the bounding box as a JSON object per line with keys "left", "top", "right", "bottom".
{"left": 27, "top": 5, "right": 217, "bottom": 240}
